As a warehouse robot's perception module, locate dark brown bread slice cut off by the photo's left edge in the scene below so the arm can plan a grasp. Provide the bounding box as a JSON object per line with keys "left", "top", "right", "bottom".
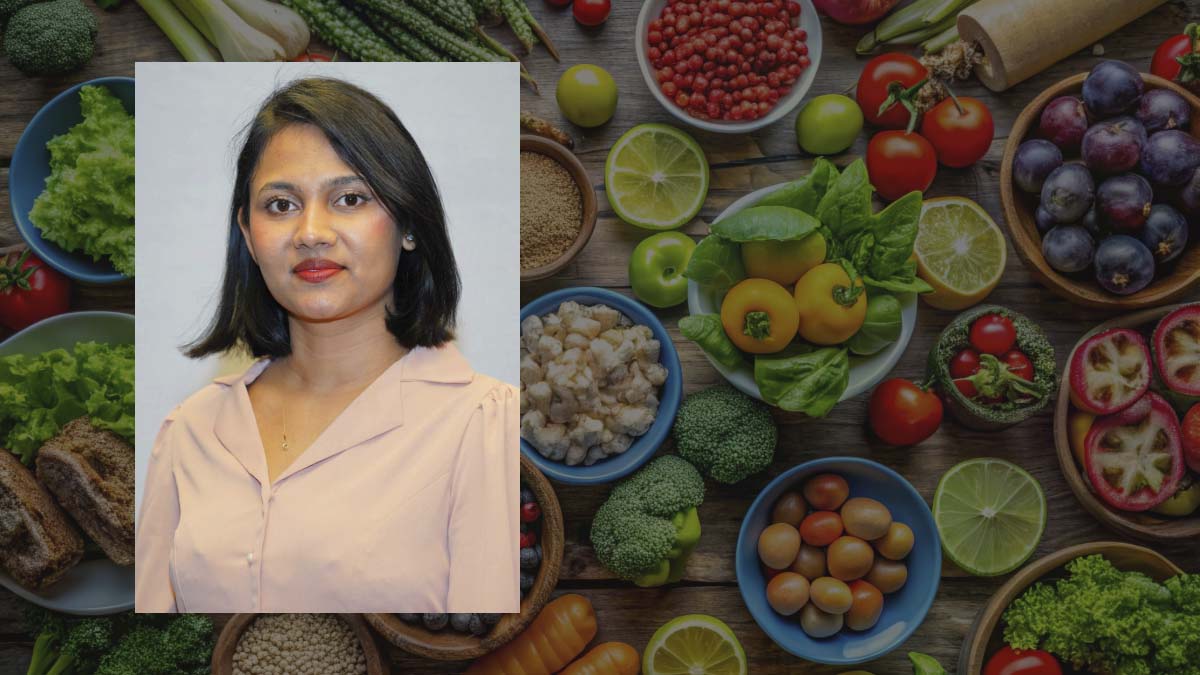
{"left": 0, "top": 448, "right": 83, "bottom": 589}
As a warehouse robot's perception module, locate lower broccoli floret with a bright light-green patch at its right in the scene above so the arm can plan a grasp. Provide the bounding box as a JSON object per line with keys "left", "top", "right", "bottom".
{"left": 592, "top": 455, "right": 704, "bottom": 586}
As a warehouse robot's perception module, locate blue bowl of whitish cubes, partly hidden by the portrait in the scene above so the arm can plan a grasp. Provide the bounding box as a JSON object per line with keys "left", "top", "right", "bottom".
{"left": 521, "top": 287, "right": 683, "bottom": 485}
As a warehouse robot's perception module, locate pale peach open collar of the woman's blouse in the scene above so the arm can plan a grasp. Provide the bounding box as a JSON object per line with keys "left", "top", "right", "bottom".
{"left": 214, "top": 342, "right": 474, "bottom": 489}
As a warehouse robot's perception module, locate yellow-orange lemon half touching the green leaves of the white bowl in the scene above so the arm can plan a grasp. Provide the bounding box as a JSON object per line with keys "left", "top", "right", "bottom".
{"left": 913, "top": 197, "right": 1008, "bottom": 310}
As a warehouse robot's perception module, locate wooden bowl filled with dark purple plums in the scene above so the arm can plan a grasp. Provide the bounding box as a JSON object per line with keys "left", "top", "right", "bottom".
{"left": 1000, "top": 73, "right": 1200, "bottom": 311}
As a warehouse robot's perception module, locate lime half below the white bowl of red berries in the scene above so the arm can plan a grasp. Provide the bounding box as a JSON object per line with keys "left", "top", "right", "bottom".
{"left": 604, "top": 124, "right": 708, "bottom": 229}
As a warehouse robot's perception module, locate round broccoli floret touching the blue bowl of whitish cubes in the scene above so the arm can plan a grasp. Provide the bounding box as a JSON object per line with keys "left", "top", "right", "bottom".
{"left": 671, "top": 386, "right": 778, "bottom": 483}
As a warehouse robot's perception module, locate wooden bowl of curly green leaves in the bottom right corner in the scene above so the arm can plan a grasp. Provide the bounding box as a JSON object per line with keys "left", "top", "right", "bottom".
{"left": 958, "top": 542, "right": 1183, "bottom": 675}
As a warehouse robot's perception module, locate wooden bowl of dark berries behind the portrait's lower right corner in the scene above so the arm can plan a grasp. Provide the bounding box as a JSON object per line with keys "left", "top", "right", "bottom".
{"left": 364, "top": 454, "right": 563, "bottom": 661}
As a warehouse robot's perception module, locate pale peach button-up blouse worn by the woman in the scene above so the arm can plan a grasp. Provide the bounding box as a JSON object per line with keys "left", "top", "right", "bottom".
{"left": 136, "top": 344, "right": 521, "bottom": 613}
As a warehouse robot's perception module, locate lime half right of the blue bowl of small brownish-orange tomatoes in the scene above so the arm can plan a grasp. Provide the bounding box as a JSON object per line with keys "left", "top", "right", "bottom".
{"left": 934, "top": 458, "right": 1046, "bottom": 577}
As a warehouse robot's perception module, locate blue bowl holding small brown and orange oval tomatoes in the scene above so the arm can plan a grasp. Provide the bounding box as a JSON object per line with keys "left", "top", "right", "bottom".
{"left": 736, "top": 458, "right": 942, "bottom": 665}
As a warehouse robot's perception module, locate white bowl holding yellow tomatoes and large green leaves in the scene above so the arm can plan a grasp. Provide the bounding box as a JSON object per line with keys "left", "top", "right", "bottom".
{"left": 688, "top": 183, "right": 917, "bottom": 401}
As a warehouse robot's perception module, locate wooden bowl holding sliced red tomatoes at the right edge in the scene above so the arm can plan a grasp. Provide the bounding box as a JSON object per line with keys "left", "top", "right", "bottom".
{"left": 1054, "top": 305, "right": 1200, "bottom": 542}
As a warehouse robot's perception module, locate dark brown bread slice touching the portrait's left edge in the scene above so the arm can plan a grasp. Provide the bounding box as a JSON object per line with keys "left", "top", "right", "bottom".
{"left": 36, "top": 417, "right": 136, "bottom": 565}
